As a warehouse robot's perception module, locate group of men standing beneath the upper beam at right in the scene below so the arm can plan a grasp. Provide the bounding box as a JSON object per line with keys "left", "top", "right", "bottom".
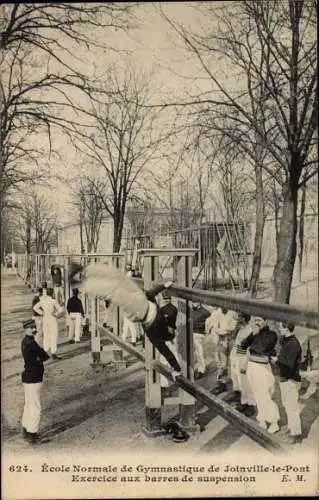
{"left": 200, "top": 309, "right": 302, "bottom": 444}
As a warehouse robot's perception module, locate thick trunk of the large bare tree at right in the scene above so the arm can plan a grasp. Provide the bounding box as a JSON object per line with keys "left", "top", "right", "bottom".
{"left": 273, "top": 181, "right": 298, "bottom": 304}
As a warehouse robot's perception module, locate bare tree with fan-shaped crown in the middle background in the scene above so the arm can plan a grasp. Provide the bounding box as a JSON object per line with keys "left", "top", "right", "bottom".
{"left": 77, "top": 70, "right": 168, "bottom": 252}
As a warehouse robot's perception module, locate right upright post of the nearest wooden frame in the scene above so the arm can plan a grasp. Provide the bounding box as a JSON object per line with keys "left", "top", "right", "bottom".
{"left": 176, "top": 255, "right": 195, "bottom": 430}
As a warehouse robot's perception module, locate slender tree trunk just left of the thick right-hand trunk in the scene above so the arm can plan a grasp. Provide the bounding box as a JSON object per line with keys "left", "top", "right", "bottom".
{"left": 250, "top": 165, "right": 265, "bottom": 298}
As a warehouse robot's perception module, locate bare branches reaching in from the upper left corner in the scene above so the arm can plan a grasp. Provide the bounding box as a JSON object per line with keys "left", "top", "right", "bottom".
{"left": 0, "top": 2, "right": 134, "bottom": 212}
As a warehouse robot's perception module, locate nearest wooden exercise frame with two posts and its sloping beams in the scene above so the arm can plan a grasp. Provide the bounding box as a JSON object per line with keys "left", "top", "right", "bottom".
{"left": 98, "top": 249, "right": 319, "bottom": 453}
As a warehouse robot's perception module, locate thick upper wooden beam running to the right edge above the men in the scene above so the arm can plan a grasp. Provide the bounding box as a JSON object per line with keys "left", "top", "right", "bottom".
{"left": 167, "top": 285, "right": 319, "bottom": 329}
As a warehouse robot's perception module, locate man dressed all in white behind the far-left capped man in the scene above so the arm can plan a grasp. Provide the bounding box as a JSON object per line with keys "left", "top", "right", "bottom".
{"left": 33, "top": 288, "right": 62, "bottom": 359}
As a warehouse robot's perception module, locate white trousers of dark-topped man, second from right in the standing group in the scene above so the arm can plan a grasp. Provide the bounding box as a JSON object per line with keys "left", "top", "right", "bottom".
{"left": 247, "top": 361, "right": 279, "bottom": 424}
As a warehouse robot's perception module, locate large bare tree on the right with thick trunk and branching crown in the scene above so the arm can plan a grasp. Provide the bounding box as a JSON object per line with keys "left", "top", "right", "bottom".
{"left": 161, "top": 0, "right": 318, "bottom": 302}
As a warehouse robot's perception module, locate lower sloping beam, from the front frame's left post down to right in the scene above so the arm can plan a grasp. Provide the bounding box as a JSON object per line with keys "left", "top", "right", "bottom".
{"left": 153, "top": 361, "right": 287, "bottom": 453}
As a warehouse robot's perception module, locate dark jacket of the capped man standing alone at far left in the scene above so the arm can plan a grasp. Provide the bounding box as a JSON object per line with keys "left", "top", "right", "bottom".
{"left": 21, "top": 335, "right": 50, "bottom": 384}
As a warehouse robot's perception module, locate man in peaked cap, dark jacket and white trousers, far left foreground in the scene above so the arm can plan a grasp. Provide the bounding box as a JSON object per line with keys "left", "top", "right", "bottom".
{"left": 21, "top": 319, "right": 50, "bottom": 444}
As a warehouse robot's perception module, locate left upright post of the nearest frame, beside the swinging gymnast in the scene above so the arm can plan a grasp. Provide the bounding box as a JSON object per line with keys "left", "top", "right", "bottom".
{"left": 144, "top": 256, "right": 163, "bottom": 436}
